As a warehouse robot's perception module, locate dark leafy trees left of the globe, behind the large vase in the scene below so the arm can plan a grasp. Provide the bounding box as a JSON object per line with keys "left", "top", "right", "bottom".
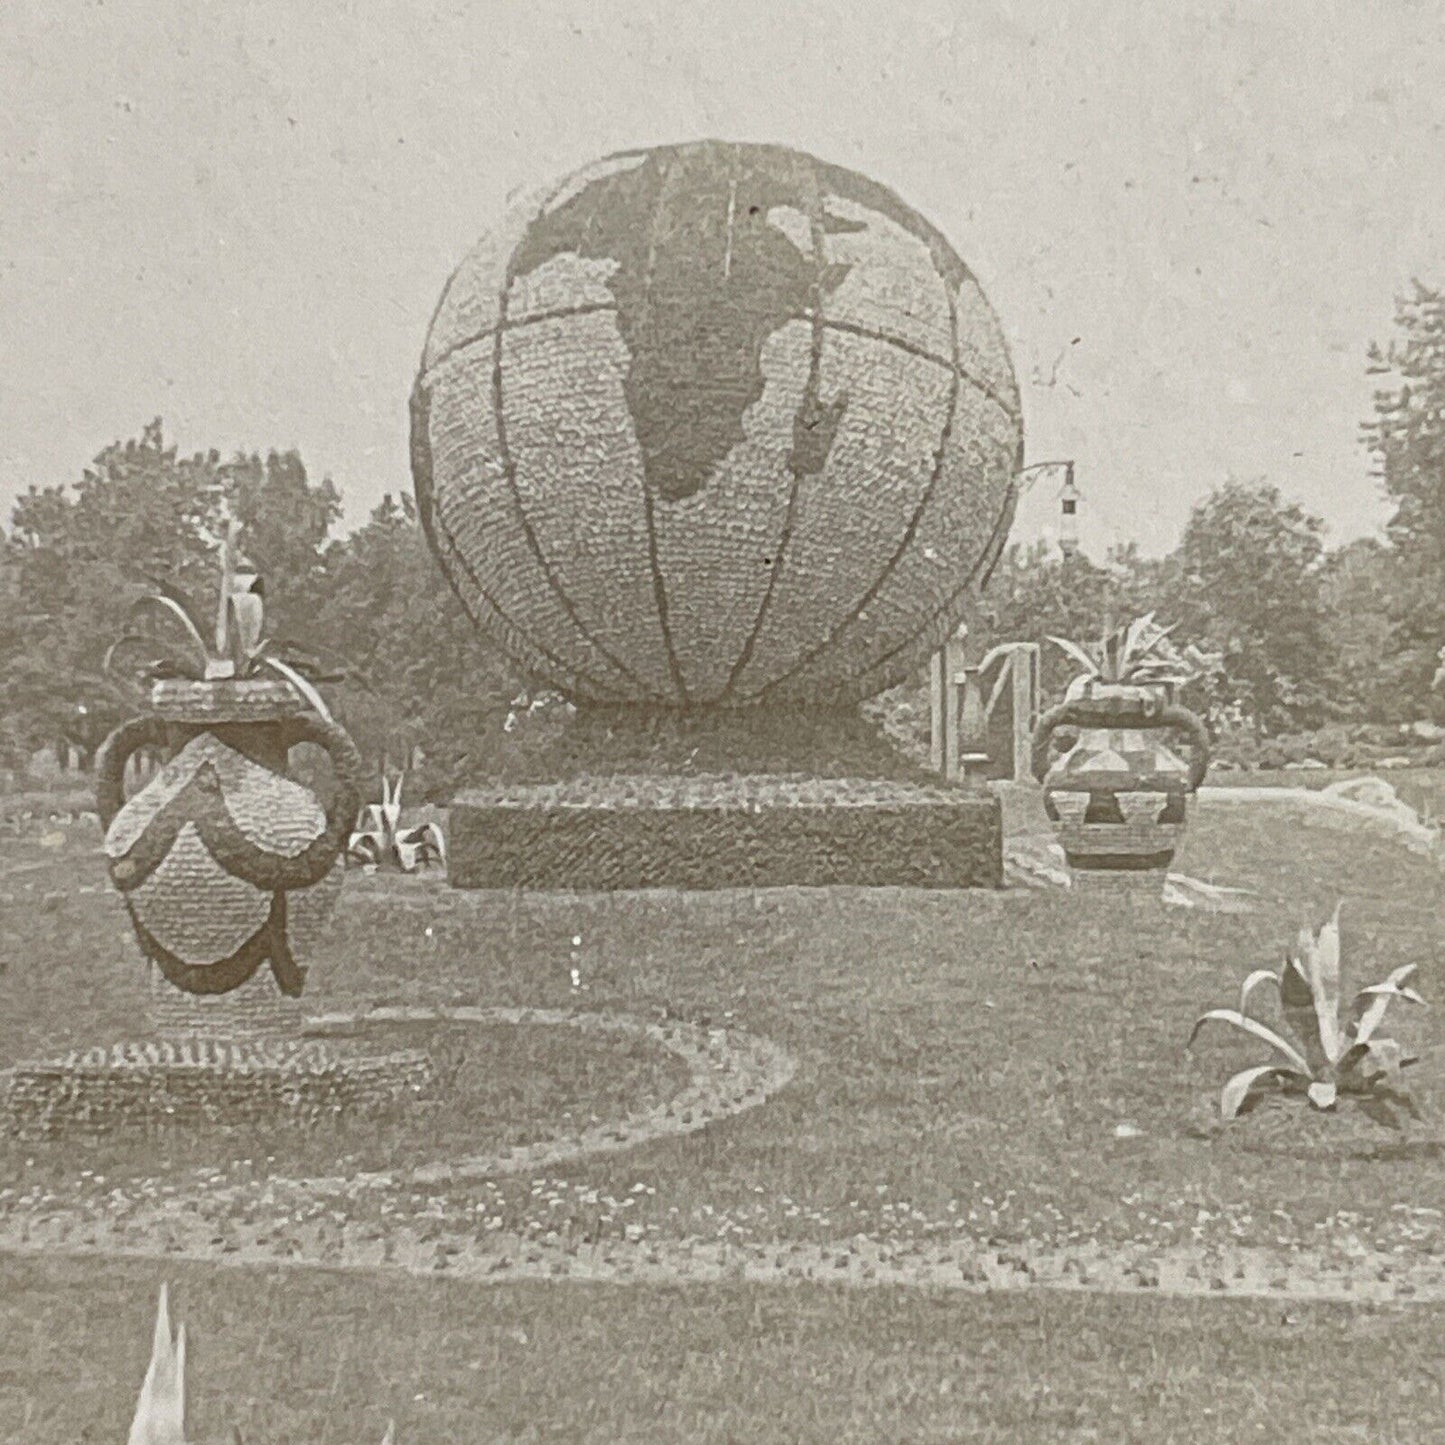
{"left": 0, "top": 420, "right": 516, "bottom": 795}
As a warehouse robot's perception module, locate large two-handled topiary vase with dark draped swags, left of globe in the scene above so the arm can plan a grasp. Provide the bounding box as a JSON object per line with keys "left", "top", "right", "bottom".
{"left": 95, "top": 678, "right": 361, "bottom": 1036}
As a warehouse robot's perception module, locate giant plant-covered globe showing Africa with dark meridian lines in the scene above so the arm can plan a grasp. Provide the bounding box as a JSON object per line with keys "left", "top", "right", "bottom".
{"left": 412, "top": 142, "right": 1022, "bottom": 708}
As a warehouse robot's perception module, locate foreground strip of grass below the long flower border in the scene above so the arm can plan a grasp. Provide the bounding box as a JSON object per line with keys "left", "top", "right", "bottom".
{"left": 0, "top": 1257, "right": 1445, "bottom": 1445}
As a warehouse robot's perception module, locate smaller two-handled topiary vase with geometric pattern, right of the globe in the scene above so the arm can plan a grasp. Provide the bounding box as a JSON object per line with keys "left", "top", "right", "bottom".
{"left": 1033, "top": 679, "right": 1209, "bottom": 874}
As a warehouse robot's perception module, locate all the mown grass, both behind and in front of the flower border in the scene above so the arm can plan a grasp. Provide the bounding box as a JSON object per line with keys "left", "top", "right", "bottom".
{"left": 0, "top": 775, "right": 1445, "bottom": 1445}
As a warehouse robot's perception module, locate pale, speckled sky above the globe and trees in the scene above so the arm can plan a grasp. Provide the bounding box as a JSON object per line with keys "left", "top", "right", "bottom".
{"left": 0, "top": 0, "right": 1445, "bottom": 549}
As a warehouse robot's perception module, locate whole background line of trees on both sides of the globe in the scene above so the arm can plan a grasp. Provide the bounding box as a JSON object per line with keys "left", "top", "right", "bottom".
{"left": 0, "top": 285, "right": 1445, "bottom": 776}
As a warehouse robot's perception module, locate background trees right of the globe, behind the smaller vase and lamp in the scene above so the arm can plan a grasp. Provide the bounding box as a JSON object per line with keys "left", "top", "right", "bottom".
{"left": 978, "top": 283, "right": 1445, "bottom": 736}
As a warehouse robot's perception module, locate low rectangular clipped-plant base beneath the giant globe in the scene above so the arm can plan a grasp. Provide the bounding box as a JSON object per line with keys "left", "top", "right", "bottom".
{"left": 448, "top": 775, "right": 1003, "bottom": 892}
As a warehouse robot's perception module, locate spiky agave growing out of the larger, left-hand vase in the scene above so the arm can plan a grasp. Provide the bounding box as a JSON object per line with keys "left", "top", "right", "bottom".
{"left": 103, "top": 522, "right": 341, "bottom": 720}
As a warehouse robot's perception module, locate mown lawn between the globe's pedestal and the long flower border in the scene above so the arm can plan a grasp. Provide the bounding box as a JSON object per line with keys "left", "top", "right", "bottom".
{"left": 0, "top": 791, "right": 1445, "bottom": 1244}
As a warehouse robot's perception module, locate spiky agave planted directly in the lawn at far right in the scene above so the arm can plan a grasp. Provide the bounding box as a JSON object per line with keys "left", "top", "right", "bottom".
{"left": 1189, "top": 907, "right": 1425, "bottom": 1123}
